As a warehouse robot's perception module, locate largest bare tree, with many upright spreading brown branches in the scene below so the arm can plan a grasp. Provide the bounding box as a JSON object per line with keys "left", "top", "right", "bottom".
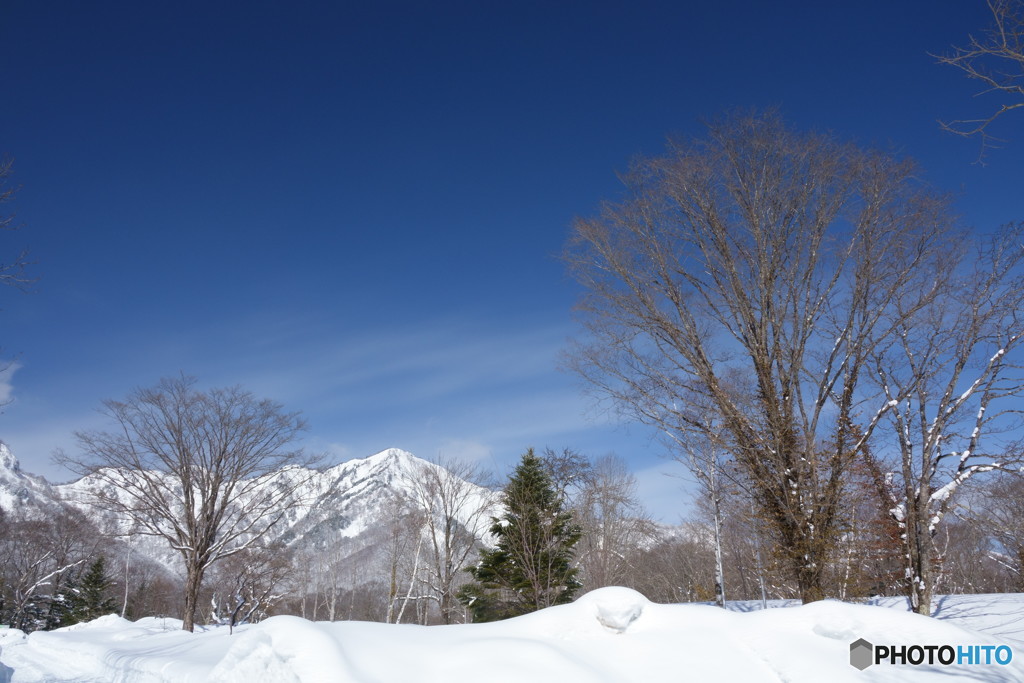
{"left": 566, "top": 113, "right": 955, "bottom": 600}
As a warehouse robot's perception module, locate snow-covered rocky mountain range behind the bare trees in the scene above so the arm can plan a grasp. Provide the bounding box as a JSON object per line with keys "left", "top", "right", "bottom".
{"left": 0, "top": 441, "right": 498, "bottom": 581}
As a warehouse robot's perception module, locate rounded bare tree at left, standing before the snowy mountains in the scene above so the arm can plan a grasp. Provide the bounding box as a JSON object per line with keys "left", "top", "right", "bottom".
{"left": 59, "top": 377, "right": 315, "bottom": 631}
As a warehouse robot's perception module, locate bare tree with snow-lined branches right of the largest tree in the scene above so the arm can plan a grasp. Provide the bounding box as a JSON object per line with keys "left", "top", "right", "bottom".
{"left": 874, "top": 223, "right": 1024, "bottom": 614}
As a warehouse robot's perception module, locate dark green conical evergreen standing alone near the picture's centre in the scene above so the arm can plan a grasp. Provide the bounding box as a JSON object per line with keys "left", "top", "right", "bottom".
{"left": 459, "top": 449, "right": 581, "bottom": 622}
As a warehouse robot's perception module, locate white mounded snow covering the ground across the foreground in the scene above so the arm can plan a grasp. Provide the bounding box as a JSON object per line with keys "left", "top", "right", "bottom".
{"left": 0, "top": 588, "right": 1024, "bottom": 683}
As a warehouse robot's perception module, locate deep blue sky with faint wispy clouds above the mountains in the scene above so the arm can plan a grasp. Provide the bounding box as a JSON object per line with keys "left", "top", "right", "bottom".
{"left": 0, "top": 0, "right": 1024, "bottom": 521}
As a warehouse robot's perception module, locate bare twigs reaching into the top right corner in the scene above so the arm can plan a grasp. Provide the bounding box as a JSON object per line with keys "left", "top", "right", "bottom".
{"left": 935, "top": 0, "right": 1024, "bottom": 152}
